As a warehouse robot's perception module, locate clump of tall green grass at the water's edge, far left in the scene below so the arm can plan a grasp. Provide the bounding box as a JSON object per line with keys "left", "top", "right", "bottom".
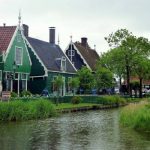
{"left": 0, "top": 100, "right": 56, "bottom": 121}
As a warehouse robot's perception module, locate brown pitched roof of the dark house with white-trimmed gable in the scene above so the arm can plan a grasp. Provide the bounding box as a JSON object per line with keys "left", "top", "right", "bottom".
{"left": 74, "top": 42, "right": 99, "bottom": 70}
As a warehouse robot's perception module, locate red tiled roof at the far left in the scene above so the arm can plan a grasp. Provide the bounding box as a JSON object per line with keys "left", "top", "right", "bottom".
{"left": 0, "top": 26, "right": 16, "bottom": 52}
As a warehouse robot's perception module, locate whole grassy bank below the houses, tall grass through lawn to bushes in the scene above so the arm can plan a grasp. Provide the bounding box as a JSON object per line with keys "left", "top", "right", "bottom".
{"left": 0, "top": 96, "right": 126, "bottom": 121}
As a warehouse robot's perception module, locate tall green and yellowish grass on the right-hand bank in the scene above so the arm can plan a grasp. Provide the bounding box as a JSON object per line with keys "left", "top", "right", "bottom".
{"left": 120, "top": 102, "right": 150, "bottom": 131}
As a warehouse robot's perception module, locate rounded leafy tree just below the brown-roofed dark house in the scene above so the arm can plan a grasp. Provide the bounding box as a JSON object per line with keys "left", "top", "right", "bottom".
{"left": 77, "top": 66, "right": 94, "bottom": 90}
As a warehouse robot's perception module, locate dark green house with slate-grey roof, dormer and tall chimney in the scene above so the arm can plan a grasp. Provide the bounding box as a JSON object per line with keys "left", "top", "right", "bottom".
{"left": 23, "top": 25, "right": 76, "bottom": 96}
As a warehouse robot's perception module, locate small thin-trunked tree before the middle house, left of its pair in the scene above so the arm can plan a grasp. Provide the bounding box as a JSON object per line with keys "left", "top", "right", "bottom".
{"left": 54, "top": 75, "right": 64, "bottom": 105}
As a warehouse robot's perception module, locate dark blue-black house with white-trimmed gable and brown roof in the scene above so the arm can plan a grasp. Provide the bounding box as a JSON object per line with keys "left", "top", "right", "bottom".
{"left": 65, "top": 37, "right": 99, "bottom": 71}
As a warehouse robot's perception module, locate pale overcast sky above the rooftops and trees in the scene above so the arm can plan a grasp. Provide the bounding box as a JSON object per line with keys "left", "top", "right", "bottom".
{"left": 0, "top": 0, "right": 150, "bottom": 54}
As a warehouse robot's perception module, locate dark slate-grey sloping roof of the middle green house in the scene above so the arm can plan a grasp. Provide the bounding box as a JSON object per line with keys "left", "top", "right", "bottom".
{"left": 26, "top": 37, "right": 76, "bottom": 73}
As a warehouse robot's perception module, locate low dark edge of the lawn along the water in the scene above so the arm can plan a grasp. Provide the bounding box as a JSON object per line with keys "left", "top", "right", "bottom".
{"left": 56, "top": 103, "right": 128, "bottom": 113}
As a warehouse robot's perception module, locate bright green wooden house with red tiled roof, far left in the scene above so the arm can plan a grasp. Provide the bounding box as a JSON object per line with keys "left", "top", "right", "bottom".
{"left": 0, "top": 24, "right": 31, "bottom": 95}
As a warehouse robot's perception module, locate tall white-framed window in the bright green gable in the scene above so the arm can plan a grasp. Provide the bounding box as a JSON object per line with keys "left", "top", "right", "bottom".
{"left": 15, "top": 47, "right": 22, "bottom": 65}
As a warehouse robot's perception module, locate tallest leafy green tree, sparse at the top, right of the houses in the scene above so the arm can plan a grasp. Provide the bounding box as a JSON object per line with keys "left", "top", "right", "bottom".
{"left": 100, "top": 29, "right": 150, "bottom": 94}
